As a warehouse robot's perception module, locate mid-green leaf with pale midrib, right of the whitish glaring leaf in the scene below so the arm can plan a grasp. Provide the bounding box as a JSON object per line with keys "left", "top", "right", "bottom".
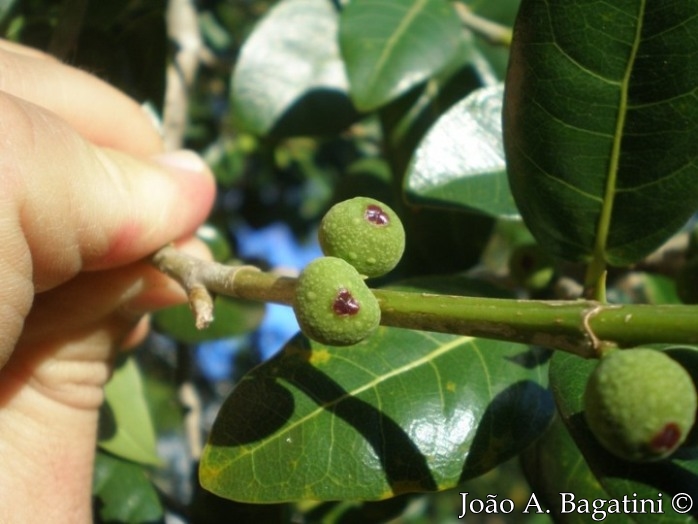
{"left": 339, "top": 0, "right": 464, "bottom": 111}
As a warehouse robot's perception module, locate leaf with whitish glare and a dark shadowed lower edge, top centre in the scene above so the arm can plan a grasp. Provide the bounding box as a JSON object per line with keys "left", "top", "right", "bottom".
{"left": 231, "top": 0, "right": 358, "bottom": 136}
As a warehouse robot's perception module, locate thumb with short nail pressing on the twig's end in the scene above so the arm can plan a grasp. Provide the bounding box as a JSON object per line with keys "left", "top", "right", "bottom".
{"left": 0, "top": 93, "right": 215, "bottom": 292}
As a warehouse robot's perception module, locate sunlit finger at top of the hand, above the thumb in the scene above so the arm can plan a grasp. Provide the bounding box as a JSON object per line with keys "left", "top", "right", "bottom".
{"left": 0, "top": 40, "right": 162, "bottom": 155}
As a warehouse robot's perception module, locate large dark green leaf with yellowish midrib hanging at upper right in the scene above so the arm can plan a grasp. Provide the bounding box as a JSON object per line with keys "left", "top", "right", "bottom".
{"left": 504, "top": 0, "right": 698, "bottom": 265}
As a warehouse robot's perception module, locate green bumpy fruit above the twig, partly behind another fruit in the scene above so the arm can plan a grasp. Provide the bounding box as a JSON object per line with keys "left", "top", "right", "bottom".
{"left": 318, "top": 197, "right": 405, "bottom": 277}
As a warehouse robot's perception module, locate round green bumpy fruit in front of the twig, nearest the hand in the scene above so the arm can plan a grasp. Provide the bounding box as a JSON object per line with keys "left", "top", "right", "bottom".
{"left": 293, "top": 257, "right": 381, "bottom": 346}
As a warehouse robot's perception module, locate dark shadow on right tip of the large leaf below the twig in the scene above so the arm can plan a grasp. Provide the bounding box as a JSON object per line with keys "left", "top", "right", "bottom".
{"left": 460, "top": 380, "right": 555, "bottom": 481}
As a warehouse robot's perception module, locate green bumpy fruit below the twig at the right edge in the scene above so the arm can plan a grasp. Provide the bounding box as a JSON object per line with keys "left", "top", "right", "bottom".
{"left": 584, "top": 348, "right": 697, "bottom": 462}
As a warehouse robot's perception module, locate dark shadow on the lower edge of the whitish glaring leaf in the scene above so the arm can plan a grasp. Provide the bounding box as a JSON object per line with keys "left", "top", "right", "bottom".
{"left": 269, "top": 88, "right": 361, "bottom": 138}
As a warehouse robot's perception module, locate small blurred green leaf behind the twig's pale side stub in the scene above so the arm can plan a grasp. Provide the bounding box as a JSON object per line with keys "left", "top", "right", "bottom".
{"left": 153, "top": 296, "right": 264, "bottom": 344}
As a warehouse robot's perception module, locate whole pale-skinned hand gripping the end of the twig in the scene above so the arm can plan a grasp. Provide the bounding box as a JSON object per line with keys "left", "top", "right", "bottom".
{"left": 0, "top": 40, "right": 215, "bottom": 524}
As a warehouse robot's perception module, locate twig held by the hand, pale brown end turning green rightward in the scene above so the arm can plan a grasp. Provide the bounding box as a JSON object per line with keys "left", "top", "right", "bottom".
{"left": 153, "top": 247, "right": 698, "bottom": 358}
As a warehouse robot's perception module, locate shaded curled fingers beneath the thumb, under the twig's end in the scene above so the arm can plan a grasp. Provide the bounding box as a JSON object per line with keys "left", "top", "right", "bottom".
{"left": 8, "top": 240, "right": 210, "bottom": 410}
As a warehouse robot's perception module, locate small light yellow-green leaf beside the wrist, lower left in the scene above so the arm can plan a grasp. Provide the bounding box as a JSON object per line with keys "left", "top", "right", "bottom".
{"left": 98, "top": 357, "right": 160, "bottom": 465}
